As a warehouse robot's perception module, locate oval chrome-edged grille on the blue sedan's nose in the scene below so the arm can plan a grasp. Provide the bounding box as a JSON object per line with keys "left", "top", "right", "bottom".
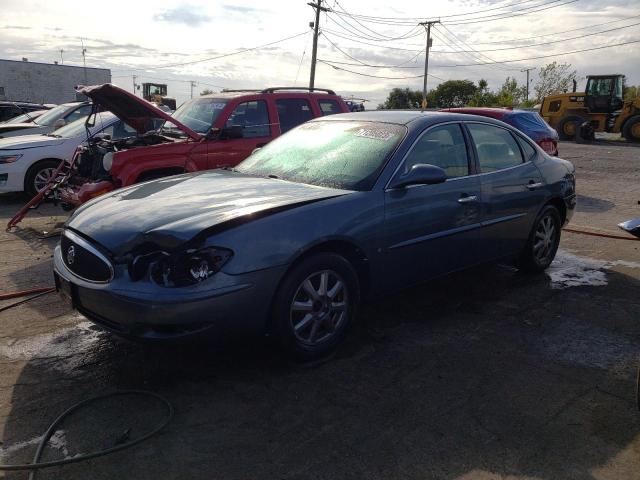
{"left": 60, "top": 230, "right": 113, "bottom": 283}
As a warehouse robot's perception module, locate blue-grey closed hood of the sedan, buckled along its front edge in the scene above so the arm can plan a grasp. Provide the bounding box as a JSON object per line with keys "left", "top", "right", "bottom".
{"left": 66, "top": 170, "right": 349, "bottom": 255}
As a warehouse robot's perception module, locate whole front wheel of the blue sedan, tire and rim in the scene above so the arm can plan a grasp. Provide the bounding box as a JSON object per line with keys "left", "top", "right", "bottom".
{"left": 272, "top": 253, "right": 360, "bottom": 360}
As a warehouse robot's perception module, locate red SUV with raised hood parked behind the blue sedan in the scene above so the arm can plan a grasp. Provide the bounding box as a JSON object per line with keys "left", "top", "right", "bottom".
{"left": 59, "top": 84, "right": 349, "bottom": 208}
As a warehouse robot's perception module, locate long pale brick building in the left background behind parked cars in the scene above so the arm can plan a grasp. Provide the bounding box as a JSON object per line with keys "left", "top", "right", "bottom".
{"left": 0, "top": 59, "right": 111, "bottom": 104}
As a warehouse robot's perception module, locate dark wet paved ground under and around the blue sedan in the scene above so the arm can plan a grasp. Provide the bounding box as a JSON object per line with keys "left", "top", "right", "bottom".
{"left": 0, "top": 143, "right": 640, "bottom": 480}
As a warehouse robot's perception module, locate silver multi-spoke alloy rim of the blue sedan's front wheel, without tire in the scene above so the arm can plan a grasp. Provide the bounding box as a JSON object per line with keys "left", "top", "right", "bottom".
{"left": 290, "top": 270, "right": 349, "bottom": 346}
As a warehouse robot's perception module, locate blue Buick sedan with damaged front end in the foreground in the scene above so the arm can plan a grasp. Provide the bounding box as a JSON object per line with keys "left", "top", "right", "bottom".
{"left": 54, "top": 111, "right": 576, "bottom": 357}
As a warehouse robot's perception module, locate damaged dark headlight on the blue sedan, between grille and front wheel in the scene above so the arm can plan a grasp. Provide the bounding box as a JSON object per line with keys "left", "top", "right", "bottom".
{"left": 129, "top": 247, "right": 233, "bottom": 287}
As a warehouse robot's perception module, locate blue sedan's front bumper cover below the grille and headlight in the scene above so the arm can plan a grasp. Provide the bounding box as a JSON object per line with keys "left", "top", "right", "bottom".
{"left": 54, "top": 246, "right": 286, "bottom": 341}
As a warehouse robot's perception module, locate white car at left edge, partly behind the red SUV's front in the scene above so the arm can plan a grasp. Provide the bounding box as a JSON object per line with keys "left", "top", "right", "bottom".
{"left": 0, "top": 112, "right": 136, "bottom": 196}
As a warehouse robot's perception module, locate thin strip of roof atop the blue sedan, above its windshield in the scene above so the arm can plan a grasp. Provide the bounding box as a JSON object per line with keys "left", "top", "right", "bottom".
{"left": 310, "top": 110, "right": 502, "bottom": 125}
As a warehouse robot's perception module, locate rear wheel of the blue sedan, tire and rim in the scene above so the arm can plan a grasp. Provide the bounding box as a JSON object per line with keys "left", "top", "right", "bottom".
{"left": 518, "top": 205, "right": 562, "bottom": 273}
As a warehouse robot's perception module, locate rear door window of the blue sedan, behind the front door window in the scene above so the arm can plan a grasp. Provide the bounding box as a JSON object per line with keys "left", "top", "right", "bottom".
{"left": 467, "top": 123, "right": 523, "bottom": 173}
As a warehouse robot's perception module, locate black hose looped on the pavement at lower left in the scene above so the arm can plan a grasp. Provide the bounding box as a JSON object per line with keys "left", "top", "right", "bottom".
{"left": 0, "top": 390, "right": 173, "bottom": 480}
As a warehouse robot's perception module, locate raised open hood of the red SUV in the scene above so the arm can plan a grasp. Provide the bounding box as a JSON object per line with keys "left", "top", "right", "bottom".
{"left": 76, "top": 83, "right": 202, "bottom": 140}
